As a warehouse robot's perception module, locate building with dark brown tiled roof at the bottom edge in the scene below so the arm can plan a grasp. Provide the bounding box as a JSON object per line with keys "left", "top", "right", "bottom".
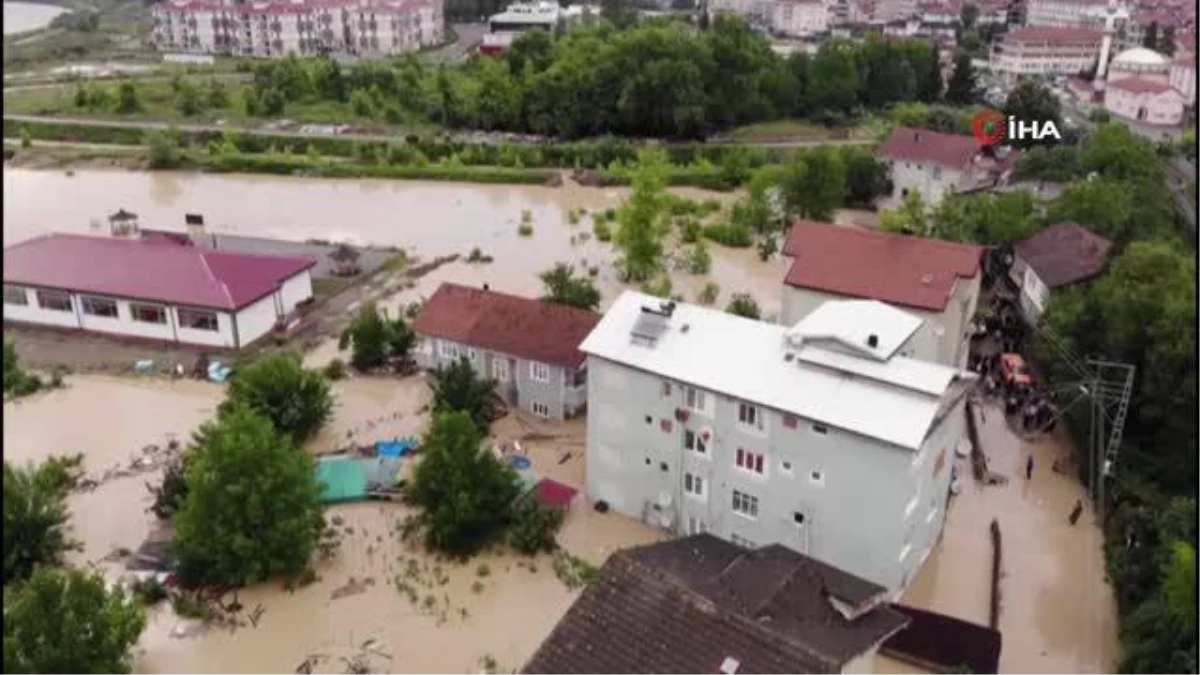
{"left": 522, "top": 534, "right": 910, "bottom": 675}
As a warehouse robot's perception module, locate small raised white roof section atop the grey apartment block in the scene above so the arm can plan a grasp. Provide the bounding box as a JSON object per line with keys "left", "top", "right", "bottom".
{"left": 787, "top": 300, "right": 923, "bottom": 360}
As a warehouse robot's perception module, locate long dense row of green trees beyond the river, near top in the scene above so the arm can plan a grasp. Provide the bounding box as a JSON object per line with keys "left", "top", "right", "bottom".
{"left": 234, "top": 17, "right": 942, "bottom": 137}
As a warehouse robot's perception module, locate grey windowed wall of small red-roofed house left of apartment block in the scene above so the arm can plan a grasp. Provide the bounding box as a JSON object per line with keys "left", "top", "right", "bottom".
{"left": 415, "top": 336, "right": 587, "bottom": 419}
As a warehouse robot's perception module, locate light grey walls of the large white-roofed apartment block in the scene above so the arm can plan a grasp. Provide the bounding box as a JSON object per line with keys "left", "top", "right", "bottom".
{"left": 587, "top": 357, "right": 962, "bottom": 591}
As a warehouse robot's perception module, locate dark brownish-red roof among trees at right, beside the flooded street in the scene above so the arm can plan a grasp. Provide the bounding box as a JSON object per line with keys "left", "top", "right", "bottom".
{"left": 1013, "top": 222, "right": 1112, "bottom": 288}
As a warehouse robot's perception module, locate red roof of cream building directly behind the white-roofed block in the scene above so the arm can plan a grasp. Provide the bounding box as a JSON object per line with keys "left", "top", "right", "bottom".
{"left": 784, "top": 220, "right": 983, "bottom": 311}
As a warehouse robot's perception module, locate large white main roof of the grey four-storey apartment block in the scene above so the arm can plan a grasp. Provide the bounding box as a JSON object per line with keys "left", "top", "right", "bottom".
{"left": 580, "top": 291, "right": 970, "bottom": 449}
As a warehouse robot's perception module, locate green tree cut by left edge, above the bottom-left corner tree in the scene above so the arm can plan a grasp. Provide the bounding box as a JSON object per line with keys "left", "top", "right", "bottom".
{"left": 4, "top": 459, "right": 79, "bottom": 584}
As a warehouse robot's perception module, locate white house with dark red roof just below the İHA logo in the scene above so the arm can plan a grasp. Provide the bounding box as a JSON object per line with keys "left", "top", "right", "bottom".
{"left": 875, "top": 126, "right": 1016, "bottom": 208}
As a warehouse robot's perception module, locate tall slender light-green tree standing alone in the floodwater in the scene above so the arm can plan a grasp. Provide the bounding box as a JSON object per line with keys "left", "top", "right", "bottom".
{"left": 613, "top": 148, "right": 670, "bottom": 281}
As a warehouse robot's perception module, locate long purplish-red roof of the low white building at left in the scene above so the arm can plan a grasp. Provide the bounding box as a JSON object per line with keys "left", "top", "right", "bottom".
{"left": 4, "top": 234, "right": 317, "bottom": 311}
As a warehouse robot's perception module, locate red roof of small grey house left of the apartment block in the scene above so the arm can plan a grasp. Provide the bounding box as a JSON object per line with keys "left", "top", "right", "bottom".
{"left": 413, "top": 283, "right": 600, "bottom": 368}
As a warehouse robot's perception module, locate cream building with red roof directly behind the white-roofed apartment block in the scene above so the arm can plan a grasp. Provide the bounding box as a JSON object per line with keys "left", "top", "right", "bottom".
{"left": 780, "top": 221, "right": 983, "bottom": 368}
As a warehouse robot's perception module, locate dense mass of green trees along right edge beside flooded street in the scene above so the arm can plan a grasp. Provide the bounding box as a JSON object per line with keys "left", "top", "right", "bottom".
{"left": 884, "top": 124, "right": 1196, "bottom": 675}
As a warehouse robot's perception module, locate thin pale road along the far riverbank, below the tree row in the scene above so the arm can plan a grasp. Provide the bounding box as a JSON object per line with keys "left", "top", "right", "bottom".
{"left": 4, "top": 114, "right": 875, "bottom": 148}
